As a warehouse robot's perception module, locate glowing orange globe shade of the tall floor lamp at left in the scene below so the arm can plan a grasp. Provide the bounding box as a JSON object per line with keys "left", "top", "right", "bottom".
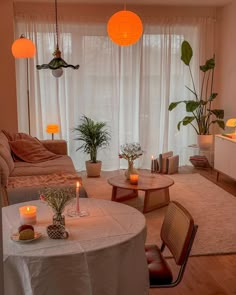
{"left": 11, "top": 35, "right": 36, "bottom": 58}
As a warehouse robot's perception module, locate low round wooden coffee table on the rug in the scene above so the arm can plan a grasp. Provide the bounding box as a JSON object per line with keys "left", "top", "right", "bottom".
{"left": 107, "top": 173, "right": 174, "bottom": 213}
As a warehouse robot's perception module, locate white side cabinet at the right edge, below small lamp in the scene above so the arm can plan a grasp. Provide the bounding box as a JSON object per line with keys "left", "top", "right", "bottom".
{"left": 214, "top": 135, "right": 236, "bottom": 179}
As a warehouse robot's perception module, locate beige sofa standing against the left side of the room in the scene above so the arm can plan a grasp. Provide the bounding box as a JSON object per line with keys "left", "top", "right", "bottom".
{"left": 0, "top": 132, "right": 87, "bottom": 206}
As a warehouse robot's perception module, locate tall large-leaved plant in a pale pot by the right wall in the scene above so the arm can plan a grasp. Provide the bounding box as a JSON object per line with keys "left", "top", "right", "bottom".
{"left": 169, "top": 41, "right": 225, "bottom": 148}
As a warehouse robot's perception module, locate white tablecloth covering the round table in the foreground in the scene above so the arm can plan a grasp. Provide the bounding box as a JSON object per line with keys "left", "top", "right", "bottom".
{"left": 3, "top": 198, "right": 149, "bottom": 295}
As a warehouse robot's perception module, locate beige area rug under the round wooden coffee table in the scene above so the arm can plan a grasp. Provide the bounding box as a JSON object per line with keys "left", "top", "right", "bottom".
{"left": 83, "top": 171, "right": 236, "bottom": 256}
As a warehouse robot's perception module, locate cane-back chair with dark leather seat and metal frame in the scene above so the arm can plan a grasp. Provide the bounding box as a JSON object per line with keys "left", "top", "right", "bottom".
{"left": 145, "top": 201, "right": 198, "bottom": 288}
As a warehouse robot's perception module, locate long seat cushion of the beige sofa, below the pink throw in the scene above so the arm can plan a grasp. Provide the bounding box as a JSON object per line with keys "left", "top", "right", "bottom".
{"left": 10, "top": 156, "right": 75, "bottom": 176}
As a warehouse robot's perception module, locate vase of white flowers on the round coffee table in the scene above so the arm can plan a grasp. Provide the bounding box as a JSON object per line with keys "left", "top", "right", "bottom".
{"left": 119, "top": 142, "right": 143, "bottom": 179}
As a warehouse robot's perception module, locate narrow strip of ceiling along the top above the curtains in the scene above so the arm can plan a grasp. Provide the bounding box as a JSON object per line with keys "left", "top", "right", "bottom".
{"left": 13, "top": 0, "right": 233, "bottom": 7}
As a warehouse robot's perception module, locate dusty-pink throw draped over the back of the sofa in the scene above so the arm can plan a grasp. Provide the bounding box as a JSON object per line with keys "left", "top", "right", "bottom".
{"left": 9, "top": 139, "right": 60, "bottom": 163}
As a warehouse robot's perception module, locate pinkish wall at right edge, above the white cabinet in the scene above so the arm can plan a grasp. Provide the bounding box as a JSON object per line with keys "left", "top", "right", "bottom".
{"left": 217, "top": 1, "right": 236, "bottom": 123}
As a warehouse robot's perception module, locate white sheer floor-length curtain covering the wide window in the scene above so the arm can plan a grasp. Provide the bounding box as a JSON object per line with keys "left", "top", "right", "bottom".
{"left": 13, "top": 14, "right": 214, "bottom": 170}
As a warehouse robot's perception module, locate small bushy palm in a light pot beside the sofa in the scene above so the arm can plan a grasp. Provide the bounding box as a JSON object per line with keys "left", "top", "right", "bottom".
{"left": 74, "top": 115, "right": 111, "bottom": 177}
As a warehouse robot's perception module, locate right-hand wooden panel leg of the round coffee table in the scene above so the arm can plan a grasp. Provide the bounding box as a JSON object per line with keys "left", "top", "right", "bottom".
{"left": 143, "top": 188, "right": 170, "bottom": 213}
